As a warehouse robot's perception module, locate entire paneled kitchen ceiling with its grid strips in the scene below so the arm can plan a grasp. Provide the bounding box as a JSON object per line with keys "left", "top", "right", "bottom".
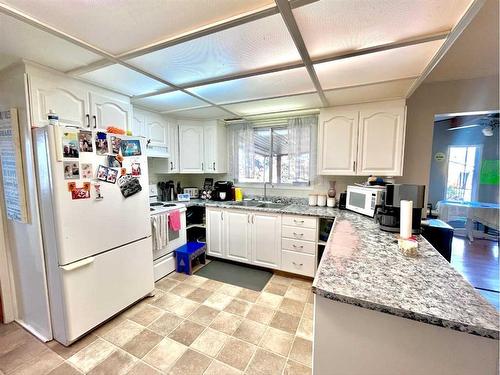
{"left": 0, "top": 0, "right": 481, "bottom": 119}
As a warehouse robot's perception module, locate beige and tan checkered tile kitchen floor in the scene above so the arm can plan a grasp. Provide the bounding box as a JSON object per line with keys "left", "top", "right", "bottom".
{"left": 0, "top": 273, "right": 313, "bottom": 375}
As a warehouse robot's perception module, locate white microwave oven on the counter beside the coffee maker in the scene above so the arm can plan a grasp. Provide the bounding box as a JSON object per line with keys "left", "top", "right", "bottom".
{"left": 346, "top": 185, "right": 385, "bottom": 217}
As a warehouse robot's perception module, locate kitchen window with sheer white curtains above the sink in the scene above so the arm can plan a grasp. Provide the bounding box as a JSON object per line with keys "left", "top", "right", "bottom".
{"left": 229, "top": 116, "right": 317, "bottom": 186}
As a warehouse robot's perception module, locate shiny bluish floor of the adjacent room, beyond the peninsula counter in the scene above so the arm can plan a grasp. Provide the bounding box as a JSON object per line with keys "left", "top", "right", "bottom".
{"left": 451, "top": 237, "right": 500, "bottom": 309}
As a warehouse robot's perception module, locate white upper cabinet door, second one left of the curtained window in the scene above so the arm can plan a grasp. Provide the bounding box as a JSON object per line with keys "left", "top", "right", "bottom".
{"left": 179, "top": 122, "right": 204, "bottom": 173}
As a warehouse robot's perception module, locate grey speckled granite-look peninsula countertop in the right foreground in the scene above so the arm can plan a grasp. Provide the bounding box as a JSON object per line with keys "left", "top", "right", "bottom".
{"left": 313, "top": 210, "right": 499, "bottom": 339}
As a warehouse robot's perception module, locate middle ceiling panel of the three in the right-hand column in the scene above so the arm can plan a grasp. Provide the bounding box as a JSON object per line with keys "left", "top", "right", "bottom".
{"left": 314, "top": 40, "right": 443, "bottom": 90}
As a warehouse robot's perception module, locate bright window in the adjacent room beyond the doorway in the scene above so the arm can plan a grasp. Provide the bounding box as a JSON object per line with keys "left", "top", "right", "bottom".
{"left": 446, "top": 146, "right": 481, "bottom": 202}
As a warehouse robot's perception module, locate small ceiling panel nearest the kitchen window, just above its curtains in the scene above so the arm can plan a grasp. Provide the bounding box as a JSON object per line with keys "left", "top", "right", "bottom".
{"left": 224, "top": 93, "right": 322, "bottom": 116}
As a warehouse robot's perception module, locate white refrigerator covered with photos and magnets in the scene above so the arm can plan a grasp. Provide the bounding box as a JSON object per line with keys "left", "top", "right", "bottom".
{"left": 33, "top": 125, "right": 154, "bottom": 345}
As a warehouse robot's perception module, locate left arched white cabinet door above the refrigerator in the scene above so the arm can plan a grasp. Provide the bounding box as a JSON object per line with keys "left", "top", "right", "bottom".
{"left": 30, "top": 76, "right": 90, "bottom": 128}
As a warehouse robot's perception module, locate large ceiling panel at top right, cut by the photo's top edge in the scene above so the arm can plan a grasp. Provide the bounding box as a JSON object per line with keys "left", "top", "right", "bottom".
{"left": 293, "top": 0, "right": 471, "bottom": 58}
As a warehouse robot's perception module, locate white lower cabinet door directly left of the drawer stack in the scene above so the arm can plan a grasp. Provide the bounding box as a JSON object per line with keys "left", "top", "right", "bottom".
{"left": 250, "top": 213, "right": 281, "bottom": 268}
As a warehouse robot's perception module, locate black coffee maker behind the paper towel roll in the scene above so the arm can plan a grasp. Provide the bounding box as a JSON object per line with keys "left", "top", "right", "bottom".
{"left": 374, "top": 184, "right": 425, "bottom": 234}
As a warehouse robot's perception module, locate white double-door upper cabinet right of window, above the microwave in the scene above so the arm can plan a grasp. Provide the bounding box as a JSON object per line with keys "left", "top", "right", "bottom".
{"left": 318, "top": 99, "right": 406, "bottom": 176}
